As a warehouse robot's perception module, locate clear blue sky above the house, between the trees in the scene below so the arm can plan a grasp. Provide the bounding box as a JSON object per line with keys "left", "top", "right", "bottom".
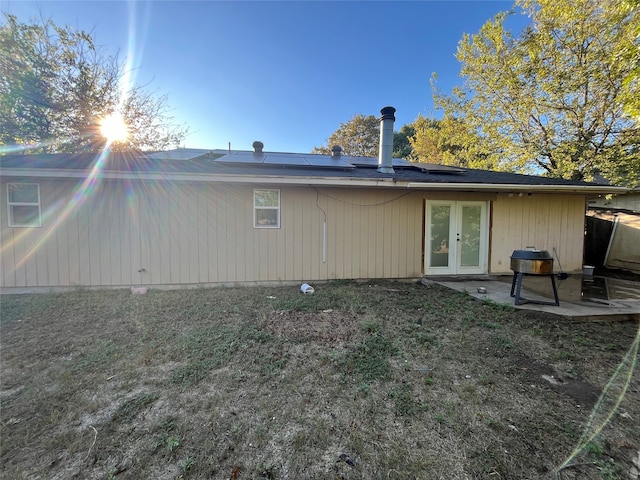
{"left": 0, "top": 0, "right": 527, "bottom": 152}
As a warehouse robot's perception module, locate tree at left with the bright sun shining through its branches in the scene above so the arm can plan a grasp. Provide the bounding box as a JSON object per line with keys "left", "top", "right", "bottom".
{"left": 0, "top": 14, "right": 187, "bottom": 153}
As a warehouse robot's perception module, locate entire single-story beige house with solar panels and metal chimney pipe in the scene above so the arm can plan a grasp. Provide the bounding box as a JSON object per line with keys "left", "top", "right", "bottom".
{"left": 0, "top": 107, "right": 616, "bottom": 291}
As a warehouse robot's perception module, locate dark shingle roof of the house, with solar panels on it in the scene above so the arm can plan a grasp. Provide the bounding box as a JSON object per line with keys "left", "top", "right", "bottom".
{"left": 0, "top": 149, "right": 612, "bottom": 187}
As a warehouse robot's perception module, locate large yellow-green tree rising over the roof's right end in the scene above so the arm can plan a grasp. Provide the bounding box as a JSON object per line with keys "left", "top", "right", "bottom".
{"left": 434, "top": 0, "right": 640, "bottom": 184}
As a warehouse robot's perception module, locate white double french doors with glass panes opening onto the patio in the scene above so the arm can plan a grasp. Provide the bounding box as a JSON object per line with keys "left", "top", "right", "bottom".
{"left": 424, "top": 200, "right": 489, "bottom": 275}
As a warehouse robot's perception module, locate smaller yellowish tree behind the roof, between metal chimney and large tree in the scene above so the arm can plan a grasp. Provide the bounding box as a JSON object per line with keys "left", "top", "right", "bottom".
{"left": 410, "top": 116, "right": 499, "bottom": 170}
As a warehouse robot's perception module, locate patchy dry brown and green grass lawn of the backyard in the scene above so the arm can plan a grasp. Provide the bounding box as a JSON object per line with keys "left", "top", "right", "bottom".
{"left": 0, "top": 282, "right": 640, "bottom": 480}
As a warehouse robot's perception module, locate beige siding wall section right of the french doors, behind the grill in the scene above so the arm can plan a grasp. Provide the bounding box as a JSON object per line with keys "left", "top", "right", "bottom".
{"left": 490, "top": 194, "right": 585, "bottom": 273}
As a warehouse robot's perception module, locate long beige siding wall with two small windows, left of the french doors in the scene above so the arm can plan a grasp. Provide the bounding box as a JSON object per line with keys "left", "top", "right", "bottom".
{"left": 0, "top": 179, "right": 423, "bottom": 287}
